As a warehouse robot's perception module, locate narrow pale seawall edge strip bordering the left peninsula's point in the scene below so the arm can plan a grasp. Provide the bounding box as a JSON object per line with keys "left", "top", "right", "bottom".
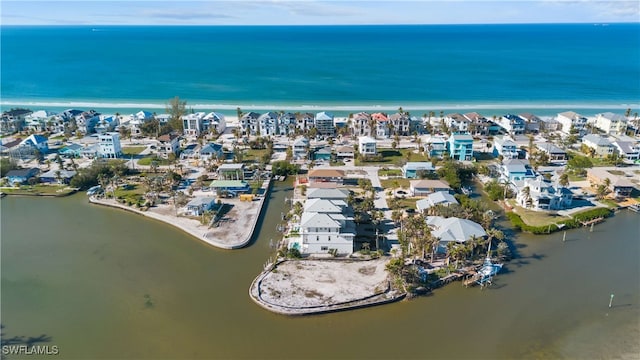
{"left": 89, "top": 180, "right": 271, "bottom": 250}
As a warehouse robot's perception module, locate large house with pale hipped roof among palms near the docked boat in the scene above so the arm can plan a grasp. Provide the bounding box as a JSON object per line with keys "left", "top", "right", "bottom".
{"left": 426, "top": 216, "right": 487, "bottom": 254}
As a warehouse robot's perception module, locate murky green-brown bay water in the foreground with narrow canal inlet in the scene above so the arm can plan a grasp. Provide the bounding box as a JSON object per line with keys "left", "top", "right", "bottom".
{"left": 0, "top": 184, "right": 640, "bottom": 359}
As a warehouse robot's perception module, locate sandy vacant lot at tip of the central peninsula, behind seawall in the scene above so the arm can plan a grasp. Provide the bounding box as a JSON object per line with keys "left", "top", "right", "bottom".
{"left": 260, "top": 258, "right": 388, "bottom": 308}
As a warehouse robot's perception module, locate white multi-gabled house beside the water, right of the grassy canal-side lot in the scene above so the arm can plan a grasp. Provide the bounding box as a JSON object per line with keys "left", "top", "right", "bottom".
{"left": 516, "top": 176, "right": 573, "bottom": 210}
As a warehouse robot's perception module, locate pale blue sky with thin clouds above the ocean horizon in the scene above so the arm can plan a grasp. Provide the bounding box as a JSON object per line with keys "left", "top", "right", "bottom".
{"left": 0, "top": 0, "right": 640, "bottom": 25}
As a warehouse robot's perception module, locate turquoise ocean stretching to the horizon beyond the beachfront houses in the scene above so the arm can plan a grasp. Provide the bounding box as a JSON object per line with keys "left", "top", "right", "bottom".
{"left": 0, "top": 23, "right": 640, "bottom": 114}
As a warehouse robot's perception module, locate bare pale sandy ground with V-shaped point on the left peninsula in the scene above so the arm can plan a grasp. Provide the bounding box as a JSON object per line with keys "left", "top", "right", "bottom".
{"left": 89, "top": 182, "right": 268, "bottom": 250}
